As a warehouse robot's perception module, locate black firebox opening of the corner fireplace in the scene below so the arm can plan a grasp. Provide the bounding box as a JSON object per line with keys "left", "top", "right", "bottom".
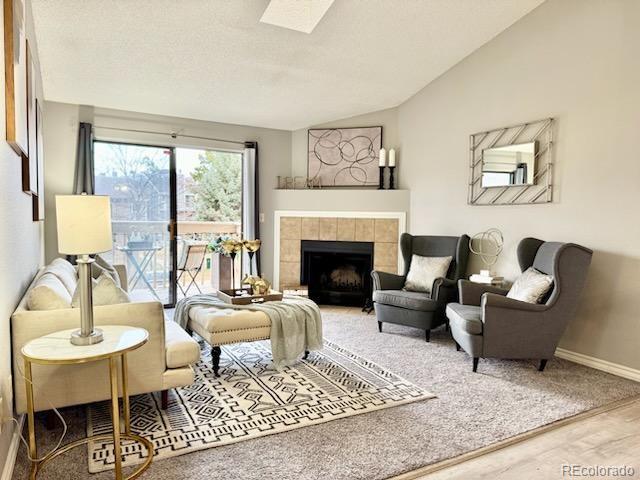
{"left": 300, "top": 240, "right": 373, "bottom": 307}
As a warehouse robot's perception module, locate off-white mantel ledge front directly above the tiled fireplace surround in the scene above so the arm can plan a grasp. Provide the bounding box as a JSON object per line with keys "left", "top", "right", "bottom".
{"left": 273, "top": 188, "right": 410, "bottom": 213}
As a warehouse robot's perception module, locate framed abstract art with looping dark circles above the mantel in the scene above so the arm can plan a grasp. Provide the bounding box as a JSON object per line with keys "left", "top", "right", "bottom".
{"left": 307, "top": 127, "right": 382, "bottom": 187}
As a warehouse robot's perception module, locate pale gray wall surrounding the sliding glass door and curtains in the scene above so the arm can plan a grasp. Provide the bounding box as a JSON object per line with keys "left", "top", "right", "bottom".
{"left": 45, "top": 102, "right": 291, "bottom": 277}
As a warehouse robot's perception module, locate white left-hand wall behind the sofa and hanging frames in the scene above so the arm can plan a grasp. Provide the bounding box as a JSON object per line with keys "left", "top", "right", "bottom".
{"left": 0, "top": 2, "right": 43, "bottom": 468}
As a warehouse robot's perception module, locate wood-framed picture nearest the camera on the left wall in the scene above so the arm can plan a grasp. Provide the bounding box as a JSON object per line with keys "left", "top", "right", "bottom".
{"left": 3, "top": 0, "right": 29, "bottom": 157}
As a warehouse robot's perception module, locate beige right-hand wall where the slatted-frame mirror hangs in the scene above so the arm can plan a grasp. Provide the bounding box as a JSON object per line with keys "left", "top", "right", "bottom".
{"left": 398, "top": 0, "right": 640, "bottom": 369}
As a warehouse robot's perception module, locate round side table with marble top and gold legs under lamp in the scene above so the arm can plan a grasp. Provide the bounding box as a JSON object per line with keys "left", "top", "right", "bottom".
{"left": 22, "top": 325, "right": 153, "bottom": 480}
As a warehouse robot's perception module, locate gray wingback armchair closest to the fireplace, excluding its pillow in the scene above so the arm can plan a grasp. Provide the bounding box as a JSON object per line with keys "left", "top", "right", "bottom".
{"left": 371, "top": 233, "right": 469, "bottom": 342}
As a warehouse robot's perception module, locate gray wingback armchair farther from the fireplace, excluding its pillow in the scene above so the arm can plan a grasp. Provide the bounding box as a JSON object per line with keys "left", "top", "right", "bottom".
{"left": 446, "top": 238, "right": 593, "bottom": 372}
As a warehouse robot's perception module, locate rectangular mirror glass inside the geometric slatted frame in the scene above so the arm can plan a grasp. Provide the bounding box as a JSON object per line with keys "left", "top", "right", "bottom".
{"left": 481, "top": 141, "right": 538, "bottom": 188}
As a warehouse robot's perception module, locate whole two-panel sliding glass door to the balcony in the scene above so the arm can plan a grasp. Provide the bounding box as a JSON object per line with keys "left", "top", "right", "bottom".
{"left": 94, "top": 140, "right": 243, "bottom": 306}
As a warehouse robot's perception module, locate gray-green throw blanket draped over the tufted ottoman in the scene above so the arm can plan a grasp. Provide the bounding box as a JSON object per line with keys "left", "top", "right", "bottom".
{"left": 173, "top": 294, "right": 322, "bottom": 368}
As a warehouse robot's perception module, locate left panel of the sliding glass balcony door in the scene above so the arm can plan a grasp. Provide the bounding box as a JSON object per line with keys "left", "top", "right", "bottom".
{"left": 94, "top": 141, "right": 177, "bottom": 306}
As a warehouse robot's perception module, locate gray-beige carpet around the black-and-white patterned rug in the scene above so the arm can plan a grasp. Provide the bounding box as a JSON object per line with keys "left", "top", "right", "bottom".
{"left": 14, "top": 309, "right": 640, "bottom": 480}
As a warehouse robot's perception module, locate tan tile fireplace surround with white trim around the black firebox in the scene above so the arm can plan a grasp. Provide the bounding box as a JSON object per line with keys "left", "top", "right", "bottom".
{"left": 273, "top": 211, "right": 406, "bottom": 290}
